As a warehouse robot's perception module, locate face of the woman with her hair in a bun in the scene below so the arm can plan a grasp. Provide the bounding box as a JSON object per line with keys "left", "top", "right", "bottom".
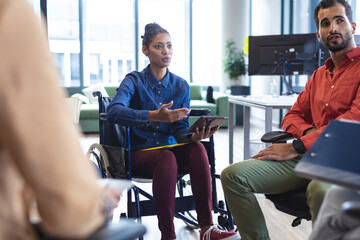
{"left": 142, "top": 33, "right": 173, "bottom": 68}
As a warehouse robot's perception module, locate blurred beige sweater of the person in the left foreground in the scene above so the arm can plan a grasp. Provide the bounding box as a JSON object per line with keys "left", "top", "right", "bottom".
{"left": 0, "top": 0, "right": 104, "bottom": 240}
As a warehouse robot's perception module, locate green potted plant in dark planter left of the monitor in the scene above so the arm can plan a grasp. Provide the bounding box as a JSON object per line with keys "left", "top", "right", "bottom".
{"left": 223, "top": 39, "right": 250, "bottom": 125}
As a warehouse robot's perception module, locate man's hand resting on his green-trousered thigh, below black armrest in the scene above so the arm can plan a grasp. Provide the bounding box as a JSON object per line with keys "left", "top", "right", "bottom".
{"left": 251, "top": 143, "right": 299, "bottom": 161}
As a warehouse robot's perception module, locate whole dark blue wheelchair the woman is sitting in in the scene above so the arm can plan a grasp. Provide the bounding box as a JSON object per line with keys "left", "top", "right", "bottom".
{"left": 88, "top": 92, "right": 234, "bottom": 237}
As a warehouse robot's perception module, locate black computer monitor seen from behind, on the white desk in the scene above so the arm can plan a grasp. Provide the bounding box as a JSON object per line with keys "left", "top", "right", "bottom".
{"left": 248, "top": 33, "right": 325, "bottom": 75}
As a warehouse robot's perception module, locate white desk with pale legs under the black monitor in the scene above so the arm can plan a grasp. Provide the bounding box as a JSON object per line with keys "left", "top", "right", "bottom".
{"left": 228, "top": 95, "right": 297, "bottom": 164}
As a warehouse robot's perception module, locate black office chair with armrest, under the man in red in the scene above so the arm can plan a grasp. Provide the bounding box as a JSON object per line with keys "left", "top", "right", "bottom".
{"left": 261, "top": 131, "right": 311, "bottom": 227}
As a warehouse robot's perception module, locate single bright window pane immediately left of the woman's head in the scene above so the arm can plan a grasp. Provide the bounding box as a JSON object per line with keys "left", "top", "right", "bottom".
{"left": 82, "top": 0, "right": 135, "bottom": 86}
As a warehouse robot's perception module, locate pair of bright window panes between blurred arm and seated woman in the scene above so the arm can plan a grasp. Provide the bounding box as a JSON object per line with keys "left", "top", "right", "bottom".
{"left": 47, "top": 0, "right": 135, "bottom": 87}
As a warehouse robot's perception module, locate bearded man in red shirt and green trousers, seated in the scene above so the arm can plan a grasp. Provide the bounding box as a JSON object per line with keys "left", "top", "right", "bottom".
{"left": 221, "top": 0, "right": 360, "bottom": 240}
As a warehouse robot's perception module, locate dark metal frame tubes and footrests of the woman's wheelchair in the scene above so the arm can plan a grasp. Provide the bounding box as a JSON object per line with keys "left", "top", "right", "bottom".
{"left": 89, "top": 92, "right": 234, "bottom": 236}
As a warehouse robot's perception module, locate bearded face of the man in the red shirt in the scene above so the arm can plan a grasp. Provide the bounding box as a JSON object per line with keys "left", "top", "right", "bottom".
{"left": 316, "top": 3, "right": 356, "bottom": 52}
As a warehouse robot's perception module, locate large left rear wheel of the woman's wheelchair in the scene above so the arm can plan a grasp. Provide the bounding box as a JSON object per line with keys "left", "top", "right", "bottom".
{"left": 86, "top": 143, "right": 111, "bottom": 178}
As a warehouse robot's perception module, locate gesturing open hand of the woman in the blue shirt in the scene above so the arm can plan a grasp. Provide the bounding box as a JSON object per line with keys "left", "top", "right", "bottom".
{"left": 148, "top": 101, "right": 190, "bottom": 122}
